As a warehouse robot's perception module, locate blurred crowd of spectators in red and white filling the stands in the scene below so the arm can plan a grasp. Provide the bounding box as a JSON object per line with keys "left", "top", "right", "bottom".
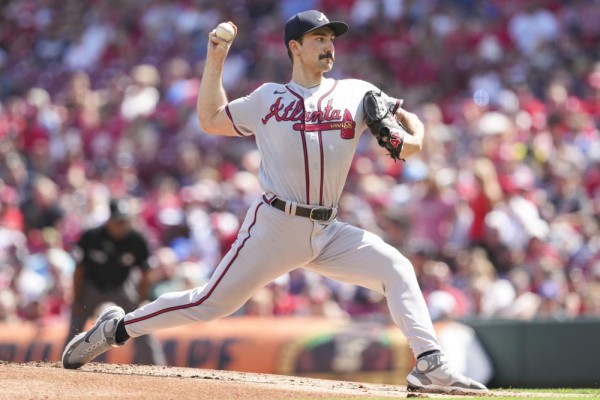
{"left": 0, "top": 0, "right": 600, "bottom": 322}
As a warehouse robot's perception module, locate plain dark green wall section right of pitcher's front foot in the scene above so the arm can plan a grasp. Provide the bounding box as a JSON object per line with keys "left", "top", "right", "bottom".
{"left": 463, "top": 318, "right": 600, "bottom": 388}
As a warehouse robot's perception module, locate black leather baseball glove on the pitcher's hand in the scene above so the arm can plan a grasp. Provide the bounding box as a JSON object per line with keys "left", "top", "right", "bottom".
{"left": 363, "top": 90, "right": 407, "bottom": 161}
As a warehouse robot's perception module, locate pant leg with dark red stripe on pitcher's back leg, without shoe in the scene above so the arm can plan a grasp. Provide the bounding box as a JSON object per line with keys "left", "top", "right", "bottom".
{"left": 125, "top": 203, "right": 312, "bottom": 337}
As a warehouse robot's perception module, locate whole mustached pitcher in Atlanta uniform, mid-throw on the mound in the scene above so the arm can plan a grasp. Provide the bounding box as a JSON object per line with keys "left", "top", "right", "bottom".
{"left": 62, "top": 10, "right": 487, "bottom": 393}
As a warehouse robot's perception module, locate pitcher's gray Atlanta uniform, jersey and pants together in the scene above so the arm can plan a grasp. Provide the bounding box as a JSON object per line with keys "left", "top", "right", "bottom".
{"left": 125, "top": 79, "right": 440, "bottom": 356}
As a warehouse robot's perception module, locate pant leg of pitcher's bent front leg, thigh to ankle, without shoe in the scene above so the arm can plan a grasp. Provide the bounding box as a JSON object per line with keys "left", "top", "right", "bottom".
{"left": 307, "top": 225, "right": 440, "bottom": 357}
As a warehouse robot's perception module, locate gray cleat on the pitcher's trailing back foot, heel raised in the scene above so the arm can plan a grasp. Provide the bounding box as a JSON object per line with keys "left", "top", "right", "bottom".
{"left": 62, "top": 306, "right": 125, "bottom": 369}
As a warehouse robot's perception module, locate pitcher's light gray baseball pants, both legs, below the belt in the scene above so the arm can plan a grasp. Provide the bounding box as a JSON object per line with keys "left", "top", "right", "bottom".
{"left": 125, "top": 199, "right": 440, "bottom": 357}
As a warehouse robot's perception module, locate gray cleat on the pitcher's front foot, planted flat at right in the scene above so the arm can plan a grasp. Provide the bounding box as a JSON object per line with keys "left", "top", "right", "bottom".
{"left": 406, "top": 353, "right": 488, "bottom": 394}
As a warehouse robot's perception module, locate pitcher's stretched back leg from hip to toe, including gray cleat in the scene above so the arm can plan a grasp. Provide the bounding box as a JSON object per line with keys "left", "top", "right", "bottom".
{"left": 61, "top": 202, "right": 314, "bottom": 368}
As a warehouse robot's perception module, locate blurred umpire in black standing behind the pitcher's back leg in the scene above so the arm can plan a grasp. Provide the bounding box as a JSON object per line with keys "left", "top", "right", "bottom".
{"left": 67, "top": 199, "right": 165, "bottom": 365}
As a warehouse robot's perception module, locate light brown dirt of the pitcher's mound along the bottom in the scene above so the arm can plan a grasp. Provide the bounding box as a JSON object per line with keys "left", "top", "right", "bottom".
{"left": 0, "top": 362, "right": 572, "bottom": 400}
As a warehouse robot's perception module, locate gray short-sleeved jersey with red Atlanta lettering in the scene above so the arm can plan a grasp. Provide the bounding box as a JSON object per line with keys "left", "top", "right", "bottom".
{"left": 226, "top": 79, "right": 401, "bottom": 207}
